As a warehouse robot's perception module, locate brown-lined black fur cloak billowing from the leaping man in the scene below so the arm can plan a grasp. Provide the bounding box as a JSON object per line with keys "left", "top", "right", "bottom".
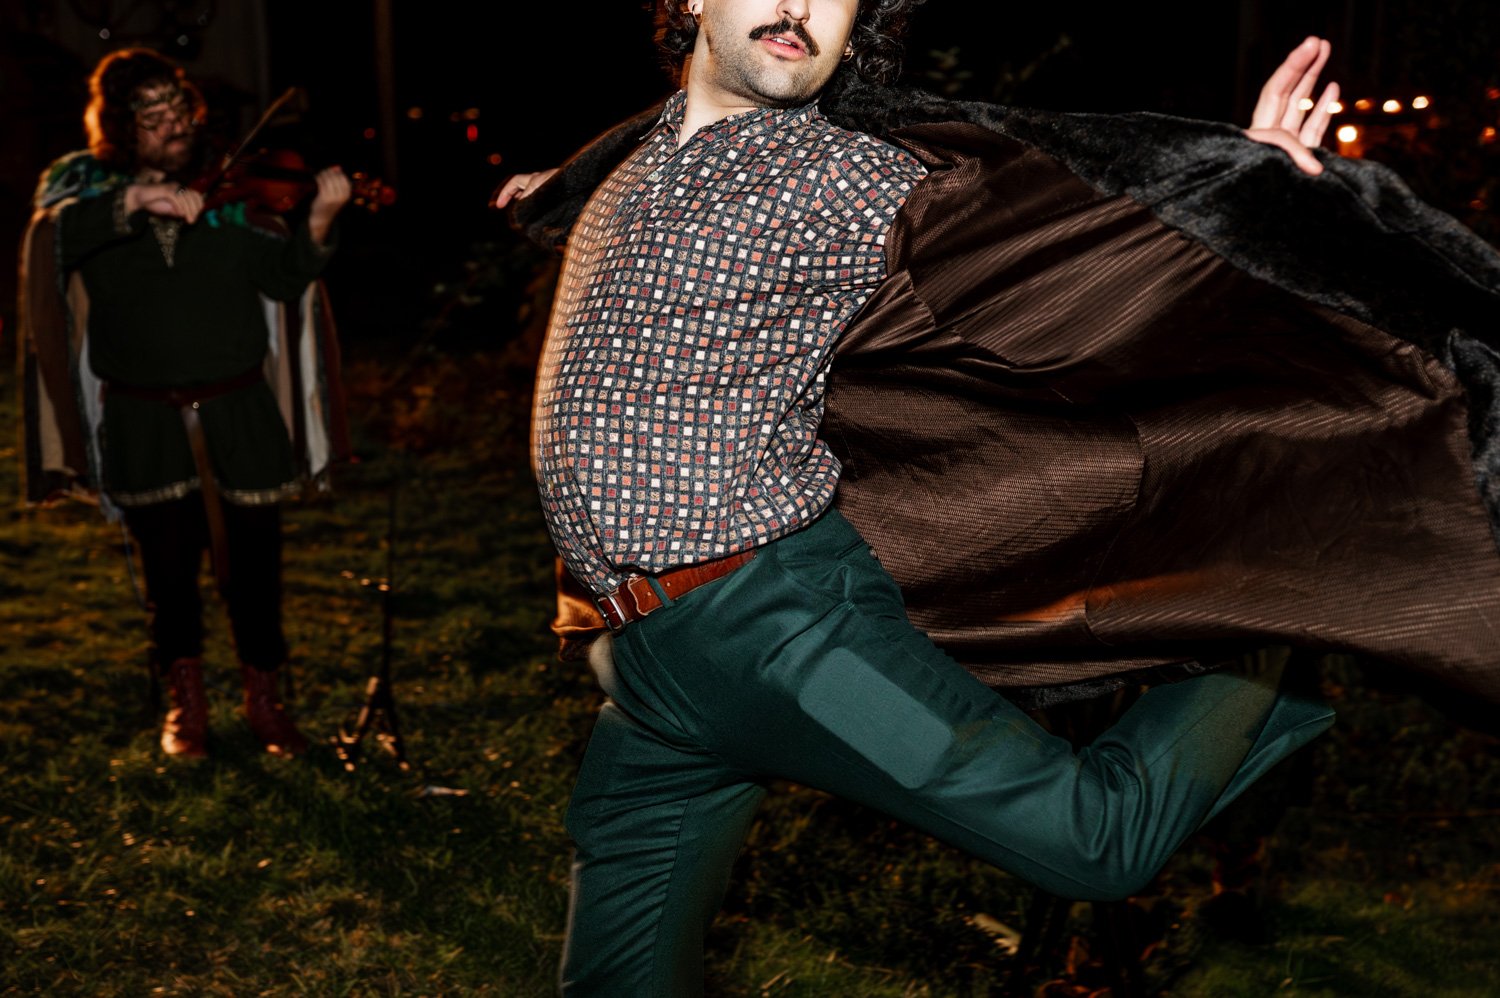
{"left": 513, "top": 86, "right": 1500, "bottom": 702}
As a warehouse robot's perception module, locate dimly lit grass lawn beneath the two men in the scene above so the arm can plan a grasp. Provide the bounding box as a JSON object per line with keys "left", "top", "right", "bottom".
{"left": 0, "top": 339, "right": 1500, "bottom": 998}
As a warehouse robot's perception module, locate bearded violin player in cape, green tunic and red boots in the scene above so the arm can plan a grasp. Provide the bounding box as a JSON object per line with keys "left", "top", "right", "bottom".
{"left": 20, "top": 48, "right": 350, "bottom": 758}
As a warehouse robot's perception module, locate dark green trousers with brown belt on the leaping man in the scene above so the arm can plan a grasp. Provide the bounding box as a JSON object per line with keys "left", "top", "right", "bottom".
{"left": 561, "top": 512, "right": 1332, "bottom": 998}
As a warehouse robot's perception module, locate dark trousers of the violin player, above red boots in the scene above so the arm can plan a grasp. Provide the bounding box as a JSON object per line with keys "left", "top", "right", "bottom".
{"left": 125, "top": 492, "right": 287, "bottom": 669}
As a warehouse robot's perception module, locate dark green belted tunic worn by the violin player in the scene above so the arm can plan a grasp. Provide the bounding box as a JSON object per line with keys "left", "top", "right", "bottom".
{"left": 59, "top": 188, "right": 329, "bottom": 506}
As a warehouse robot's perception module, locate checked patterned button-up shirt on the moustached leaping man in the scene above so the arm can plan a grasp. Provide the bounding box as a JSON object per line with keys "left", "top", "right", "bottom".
{"left": 533, "top": 93, "right": 924, "bottom": 593}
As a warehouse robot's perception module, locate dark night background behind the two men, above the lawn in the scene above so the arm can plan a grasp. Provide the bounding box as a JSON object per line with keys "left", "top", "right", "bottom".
{"left": 0, "top": 0, "right": 1500, "bottom": 354}
